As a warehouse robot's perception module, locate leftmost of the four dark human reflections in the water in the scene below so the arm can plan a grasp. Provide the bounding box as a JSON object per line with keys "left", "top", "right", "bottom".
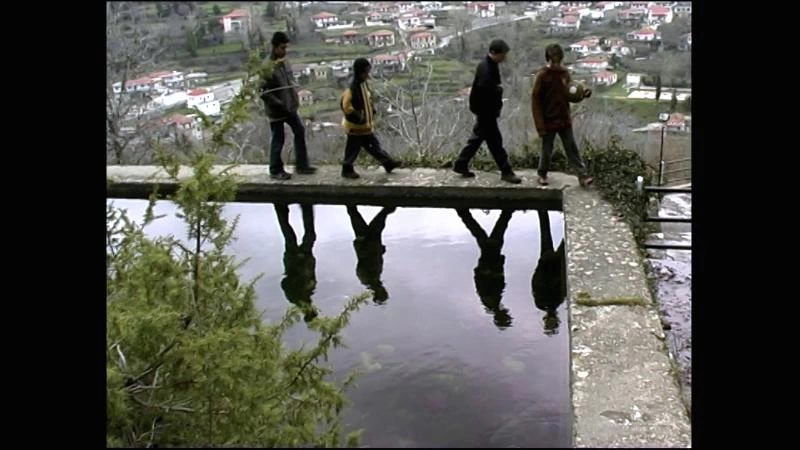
{"left": 275, "top": 203, "right": 317, "bottom": 322}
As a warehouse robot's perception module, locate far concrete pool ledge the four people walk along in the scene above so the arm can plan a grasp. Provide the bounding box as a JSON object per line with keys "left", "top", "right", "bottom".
{"left": 106, "top": 165, "right": 564, "bottom": 211}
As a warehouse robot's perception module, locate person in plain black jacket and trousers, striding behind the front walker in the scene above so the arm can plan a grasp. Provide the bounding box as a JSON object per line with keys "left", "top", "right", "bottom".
{"left": 453, "top": 39, "right": 522, "bottom": 183}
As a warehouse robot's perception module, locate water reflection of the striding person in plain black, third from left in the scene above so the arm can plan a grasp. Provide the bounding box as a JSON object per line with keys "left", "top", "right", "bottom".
{"left": 456, "top": 208, "right": 514, "bottom": 330}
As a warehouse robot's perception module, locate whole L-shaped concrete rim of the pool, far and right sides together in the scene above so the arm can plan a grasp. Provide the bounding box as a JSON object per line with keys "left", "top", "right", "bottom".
{"left": 106, "top": 165, "right": 691, "bottom": 447}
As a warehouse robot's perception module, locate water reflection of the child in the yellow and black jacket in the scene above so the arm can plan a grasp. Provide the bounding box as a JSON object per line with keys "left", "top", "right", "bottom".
{"left": 347, "top": 205, "right": 396, "bottom": 303}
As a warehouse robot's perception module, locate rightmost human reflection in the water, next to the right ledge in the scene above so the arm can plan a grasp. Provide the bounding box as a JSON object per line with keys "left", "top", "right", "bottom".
{"left": 531, "top": 211, "right": 567, "bottom": 336}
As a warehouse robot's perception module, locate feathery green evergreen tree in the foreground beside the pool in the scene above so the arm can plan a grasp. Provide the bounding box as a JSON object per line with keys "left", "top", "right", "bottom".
{"left": 106, "top": 52, "right": 366, "bottom": 447}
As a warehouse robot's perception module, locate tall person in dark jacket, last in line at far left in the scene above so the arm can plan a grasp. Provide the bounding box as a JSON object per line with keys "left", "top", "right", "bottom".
{"left": 261, "top": 31, "right": 317, "bottom": 180}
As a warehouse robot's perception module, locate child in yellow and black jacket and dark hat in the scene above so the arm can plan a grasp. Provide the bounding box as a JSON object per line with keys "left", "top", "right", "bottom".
{"left": 340, "top": 58, "right": 400, "bottom": 178}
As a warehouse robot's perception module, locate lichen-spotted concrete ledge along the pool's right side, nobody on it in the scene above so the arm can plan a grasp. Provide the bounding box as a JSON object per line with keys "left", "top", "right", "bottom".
{"left": 564, "top": 183, "right": 691, "bottom": 447}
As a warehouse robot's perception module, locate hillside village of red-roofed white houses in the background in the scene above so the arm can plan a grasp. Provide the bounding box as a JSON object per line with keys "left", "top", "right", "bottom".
{"left": 111, "top": 1, "right": 691, "bottom": 149}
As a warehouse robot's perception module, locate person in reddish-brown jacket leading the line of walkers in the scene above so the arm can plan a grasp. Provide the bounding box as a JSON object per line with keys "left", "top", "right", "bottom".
{"left": 531, "top": 44, "right": 592, "bottom": 187}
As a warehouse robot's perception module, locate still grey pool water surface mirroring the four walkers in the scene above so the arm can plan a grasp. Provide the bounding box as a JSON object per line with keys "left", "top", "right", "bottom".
{"left": 113, "top": 200, "right": 572, "bottom": 447}
